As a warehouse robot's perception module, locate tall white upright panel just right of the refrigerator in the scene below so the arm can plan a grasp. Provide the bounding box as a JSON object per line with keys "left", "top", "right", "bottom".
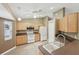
{"left": 48, "top": 19, "right": 55, "bottom": 43}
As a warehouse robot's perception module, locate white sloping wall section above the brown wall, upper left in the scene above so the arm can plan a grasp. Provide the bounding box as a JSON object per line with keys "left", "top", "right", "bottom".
{"left": 0, "top": 4, "right": 14, "bottom": 20}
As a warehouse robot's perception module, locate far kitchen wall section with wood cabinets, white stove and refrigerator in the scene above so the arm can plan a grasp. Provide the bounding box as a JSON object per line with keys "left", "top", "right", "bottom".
{"left": 16, "top": 17, "right": 48, "bottom": 45}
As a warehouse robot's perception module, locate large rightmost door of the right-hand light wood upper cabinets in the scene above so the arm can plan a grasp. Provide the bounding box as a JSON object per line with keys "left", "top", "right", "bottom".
{"left": 68, "top": 13, "right": 78, "bottom": 32}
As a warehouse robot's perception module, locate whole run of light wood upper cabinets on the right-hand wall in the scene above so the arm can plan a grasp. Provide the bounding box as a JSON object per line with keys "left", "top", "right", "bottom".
{"left": 58, "top": 13, "right": 78, "bottom": 32}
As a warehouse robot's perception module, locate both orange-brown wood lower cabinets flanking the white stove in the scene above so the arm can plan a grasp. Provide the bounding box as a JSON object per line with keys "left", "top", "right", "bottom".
{"left": 16, "top": 33, "right": 40, "bottom": 45}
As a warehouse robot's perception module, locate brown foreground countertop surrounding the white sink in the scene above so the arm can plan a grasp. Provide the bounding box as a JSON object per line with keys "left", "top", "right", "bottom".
{"left": 39, "top": 40, "right": 79, "bottom": 55}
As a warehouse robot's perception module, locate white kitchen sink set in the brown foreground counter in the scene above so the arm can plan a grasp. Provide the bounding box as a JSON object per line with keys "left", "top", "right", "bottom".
{"left": 43, "top": 42, "right": 64, "bottom": 53}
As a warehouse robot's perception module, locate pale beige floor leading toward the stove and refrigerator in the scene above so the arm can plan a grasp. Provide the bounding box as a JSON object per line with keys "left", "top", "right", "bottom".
{"left": 5, "top": 41, "right": 47, "bottom": 55}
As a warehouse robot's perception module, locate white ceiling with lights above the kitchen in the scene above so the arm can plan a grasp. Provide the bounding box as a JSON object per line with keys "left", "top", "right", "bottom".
{"left": 2, "top": 3, "right": 79, "bottom": 19}
